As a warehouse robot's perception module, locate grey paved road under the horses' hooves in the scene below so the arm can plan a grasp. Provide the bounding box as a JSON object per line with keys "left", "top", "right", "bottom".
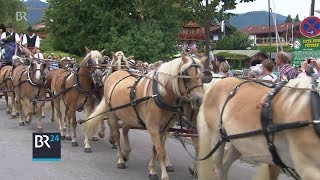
{"left": 0, "top": 99, "right": 292, "bottom": 180}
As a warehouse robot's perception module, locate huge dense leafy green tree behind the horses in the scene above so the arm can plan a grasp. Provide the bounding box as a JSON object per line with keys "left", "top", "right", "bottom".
{"left": 46, "top": 0, "right": 188, "bottom": 61}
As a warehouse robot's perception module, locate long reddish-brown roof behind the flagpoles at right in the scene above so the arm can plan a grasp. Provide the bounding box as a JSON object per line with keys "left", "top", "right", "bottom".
{"left": 240, "top": 22, "right": 300, "bottom": 34}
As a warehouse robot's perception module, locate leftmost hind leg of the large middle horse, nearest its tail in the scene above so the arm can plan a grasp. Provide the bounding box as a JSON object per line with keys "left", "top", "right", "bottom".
{"left": 109, "top": 113, "right": 126, "bottom": 169}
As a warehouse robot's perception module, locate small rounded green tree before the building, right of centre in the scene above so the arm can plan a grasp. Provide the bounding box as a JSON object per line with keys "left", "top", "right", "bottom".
{"left": 216, "top": 31, "right": 250, "bottom": 50}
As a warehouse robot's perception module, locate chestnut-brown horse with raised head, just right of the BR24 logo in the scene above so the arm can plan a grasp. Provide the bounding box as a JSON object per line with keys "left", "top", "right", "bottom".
{"left": 51, "top": 48, "right": 104, "bottom": 146}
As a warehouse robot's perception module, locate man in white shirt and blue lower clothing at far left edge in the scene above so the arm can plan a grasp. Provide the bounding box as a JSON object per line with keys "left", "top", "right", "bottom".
{"left": 1, "top": 23, "right": 20, "bottom": 65}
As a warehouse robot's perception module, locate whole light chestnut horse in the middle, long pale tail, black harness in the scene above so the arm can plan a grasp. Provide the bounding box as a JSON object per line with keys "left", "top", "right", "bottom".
{"left": 85, "top": 53, "right": 206, "bottom": 179}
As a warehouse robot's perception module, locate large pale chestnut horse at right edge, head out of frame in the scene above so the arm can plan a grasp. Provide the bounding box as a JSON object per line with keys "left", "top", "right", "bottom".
{"left": 197, "top": 78, "right": 320, "bottom": 180}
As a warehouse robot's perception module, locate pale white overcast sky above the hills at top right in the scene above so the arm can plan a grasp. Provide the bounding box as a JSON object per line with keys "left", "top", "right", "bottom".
{"left": 231, "top": 0, "right": 320, "bottom": 20}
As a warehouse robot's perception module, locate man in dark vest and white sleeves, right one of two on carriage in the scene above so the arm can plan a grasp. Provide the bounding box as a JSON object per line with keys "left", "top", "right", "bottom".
{"left": 22, "top": 27, "right": 40, "bottom": 54}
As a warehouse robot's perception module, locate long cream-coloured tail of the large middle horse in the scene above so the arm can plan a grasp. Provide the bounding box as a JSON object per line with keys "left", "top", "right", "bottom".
{"left": 84, "top": 97, "right": 107, "bottom": 137}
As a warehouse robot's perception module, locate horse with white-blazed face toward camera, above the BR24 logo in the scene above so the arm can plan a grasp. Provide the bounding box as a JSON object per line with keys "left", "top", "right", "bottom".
{"left": 12, "top": 60, "right": 47, "bottom": 132}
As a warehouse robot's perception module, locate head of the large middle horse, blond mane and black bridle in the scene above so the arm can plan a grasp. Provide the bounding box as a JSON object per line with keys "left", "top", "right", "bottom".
{"left": 159, "top": 52, "right": 207, "bottom": 108}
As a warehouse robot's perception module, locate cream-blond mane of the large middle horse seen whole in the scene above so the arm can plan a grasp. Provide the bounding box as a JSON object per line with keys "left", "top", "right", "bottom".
{"left": 158, "top": 56, "right": 203, "bottom": 96}
